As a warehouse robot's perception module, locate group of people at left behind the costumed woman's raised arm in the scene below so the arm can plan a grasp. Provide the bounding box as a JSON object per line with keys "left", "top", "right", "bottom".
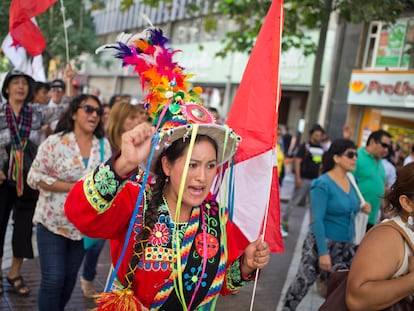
{"left": 0, "top": 66, "right": 155, "bottom": 310}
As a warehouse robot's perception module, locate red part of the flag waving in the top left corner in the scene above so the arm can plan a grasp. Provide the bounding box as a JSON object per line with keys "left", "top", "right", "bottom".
{"left": 9, "top": 0, "right": 56, "bottom": 56}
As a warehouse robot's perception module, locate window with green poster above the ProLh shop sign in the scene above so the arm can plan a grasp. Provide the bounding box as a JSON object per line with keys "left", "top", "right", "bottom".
{"left": 364, "top": 18, "right": 414, "bottom": 69}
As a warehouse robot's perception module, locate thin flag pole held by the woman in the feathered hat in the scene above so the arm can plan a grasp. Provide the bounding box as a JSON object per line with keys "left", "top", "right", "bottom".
{"left": 250, "top": 1, "right": 284, "bottom": 311}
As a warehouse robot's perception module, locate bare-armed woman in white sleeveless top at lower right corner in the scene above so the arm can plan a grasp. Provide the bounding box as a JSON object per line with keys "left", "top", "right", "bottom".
{"left": 346, "top": 163, "right": 414, "bottom": 311}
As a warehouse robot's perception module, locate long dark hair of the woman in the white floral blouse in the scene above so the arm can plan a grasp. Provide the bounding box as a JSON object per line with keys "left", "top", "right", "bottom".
{"left": 55, "top": 94, "right": 105, "bottom": 138}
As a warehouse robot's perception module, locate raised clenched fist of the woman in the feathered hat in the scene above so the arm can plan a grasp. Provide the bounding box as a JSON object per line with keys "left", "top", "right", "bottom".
{"left": 114, "top": 122, "right": 155, "bottom": 176}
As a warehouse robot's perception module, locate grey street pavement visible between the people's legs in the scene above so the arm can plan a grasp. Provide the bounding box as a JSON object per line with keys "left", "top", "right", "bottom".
{"left": 0, "top": 174, "right": 323, "bottom": 311}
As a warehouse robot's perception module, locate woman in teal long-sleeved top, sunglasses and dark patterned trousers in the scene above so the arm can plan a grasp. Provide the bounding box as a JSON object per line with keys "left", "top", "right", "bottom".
{"left": 283, "top": 139, "right": 371, "bottom": 311}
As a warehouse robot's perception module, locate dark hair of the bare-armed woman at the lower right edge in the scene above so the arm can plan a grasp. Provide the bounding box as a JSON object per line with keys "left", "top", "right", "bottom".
{"left": 384, "top": 162, "right": 414, "bottom": 214}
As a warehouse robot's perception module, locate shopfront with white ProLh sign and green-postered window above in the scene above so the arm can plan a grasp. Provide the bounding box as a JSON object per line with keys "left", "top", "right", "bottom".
{"left": 346, "top": 16, "right": 414, "bottom": 153}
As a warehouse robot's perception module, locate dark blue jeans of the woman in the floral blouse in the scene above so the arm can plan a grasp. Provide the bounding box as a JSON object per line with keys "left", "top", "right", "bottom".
{"left": 37, "top": 224, "right": 85, "bottom": 311}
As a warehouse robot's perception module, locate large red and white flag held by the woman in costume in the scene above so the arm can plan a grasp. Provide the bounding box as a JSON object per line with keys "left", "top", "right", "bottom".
{"left": 227, "top": 0, "right": 283, "bottom": 252}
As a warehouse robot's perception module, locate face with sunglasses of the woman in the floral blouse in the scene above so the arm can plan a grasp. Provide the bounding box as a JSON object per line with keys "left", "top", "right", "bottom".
{"left": 72, "top": 98, "right": 102, "bottom": 134}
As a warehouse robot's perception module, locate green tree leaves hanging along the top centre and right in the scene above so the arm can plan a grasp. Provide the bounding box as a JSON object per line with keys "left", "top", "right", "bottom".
{"left": 121, "top": 0, "right": 412, "bottom": 56}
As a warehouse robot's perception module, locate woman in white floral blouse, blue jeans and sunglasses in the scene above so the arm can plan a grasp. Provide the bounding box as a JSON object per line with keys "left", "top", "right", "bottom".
{"left": 27, "top": 94, "right": 111, "bottom": 311}
